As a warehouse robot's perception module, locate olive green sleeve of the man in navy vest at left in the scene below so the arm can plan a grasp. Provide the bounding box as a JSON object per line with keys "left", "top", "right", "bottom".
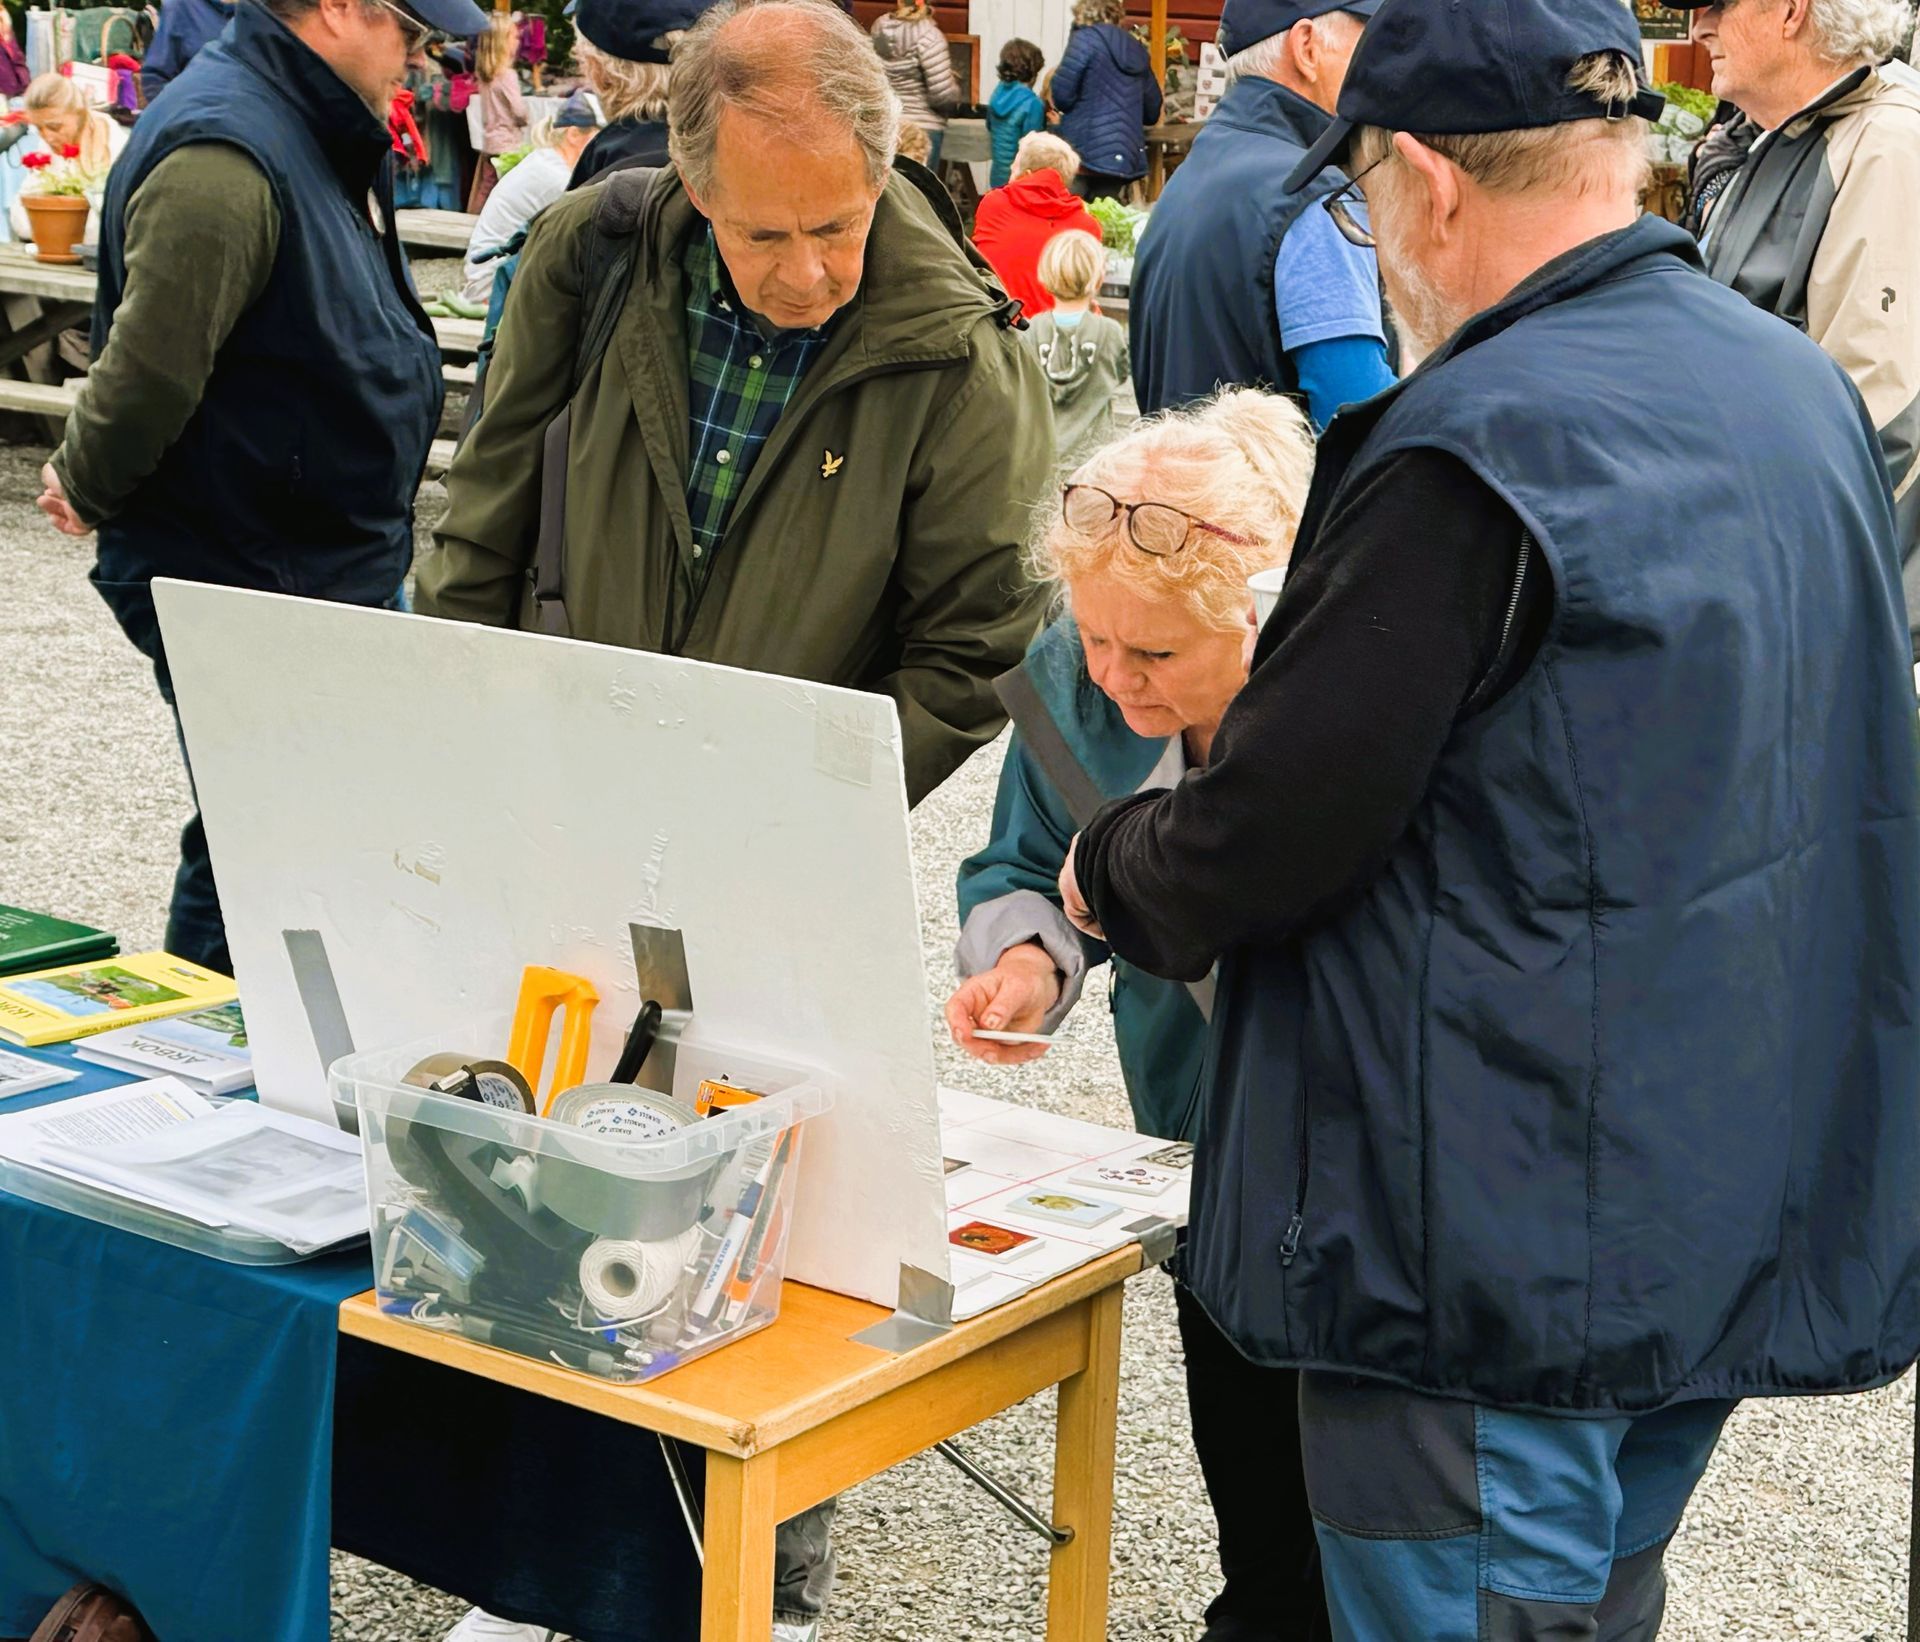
{"left": 54, "top": 142, "right": 280, "bottom": 524}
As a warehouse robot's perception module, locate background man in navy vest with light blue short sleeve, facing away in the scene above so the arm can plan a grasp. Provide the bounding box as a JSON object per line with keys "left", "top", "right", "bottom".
{"left": 1133, "top": 0, "right": 1394, "bottom": 428}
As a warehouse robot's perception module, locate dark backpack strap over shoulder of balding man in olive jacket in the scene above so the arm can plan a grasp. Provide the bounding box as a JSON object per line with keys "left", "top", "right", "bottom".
{"left": 532, "top": 165, "right": 660, "bottom": 638}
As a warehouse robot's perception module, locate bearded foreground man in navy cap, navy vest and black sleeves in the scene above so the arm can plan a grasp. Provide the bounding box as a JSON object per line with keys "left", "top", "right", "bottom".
{"left": 1062, "top": 0, "right": 1920, "bottom": 1642}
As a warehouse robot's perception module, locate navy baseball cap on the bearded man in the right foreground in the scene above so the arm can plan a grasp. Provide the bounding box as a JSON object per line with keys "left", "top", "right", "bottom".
{"left": 1286, "top": 0, "right": 1667, "bottom": 188}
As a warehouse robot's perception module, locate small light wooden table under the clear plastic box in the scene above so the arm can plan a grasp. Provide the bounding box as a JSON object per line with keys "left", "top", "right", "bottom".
{"left": 340, "top": 1244, "right": 1144, "bottom": 1642}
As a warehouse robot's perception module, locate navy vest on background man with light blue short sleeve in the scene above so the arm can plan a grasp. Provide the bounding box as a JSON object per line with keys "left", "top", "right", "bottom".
{"left": 1129, "top": 75, "right": 1346, "bottom": 415}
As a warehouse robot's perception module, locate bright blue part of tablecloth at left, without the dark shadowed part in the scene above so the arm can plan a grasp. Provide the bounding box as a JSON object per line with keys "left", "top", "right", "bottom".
{"left": 0, "top": 1050, "right": 371, "bottom": 1642}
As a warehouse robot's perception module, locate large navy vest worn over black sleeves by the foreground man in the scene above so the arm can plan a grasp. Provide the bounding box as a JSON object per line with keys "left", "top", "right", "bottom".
{"left": 1188, "top": 217, "right": 1920, "bottom": 1412}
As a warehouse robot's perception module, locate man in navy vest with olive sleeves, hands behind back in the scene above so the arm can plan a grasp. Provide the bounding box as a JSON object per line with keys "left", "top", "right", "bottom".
{"left": 40, "top": 0, "right": 486, "bottom": 974}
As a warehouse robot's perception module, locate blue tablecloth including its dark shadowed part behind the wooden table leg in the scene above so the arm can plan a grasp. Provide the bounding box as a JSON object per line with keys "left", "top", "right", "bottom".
{"left": 0, "top": 1050, "right": 699, "bottom": 1642}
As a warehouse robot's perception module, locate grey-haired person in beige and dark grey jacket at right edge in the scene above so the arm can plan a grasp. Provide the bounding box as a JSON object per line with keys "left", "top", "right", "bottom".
{"left": 1676, "top": 0, "right": 1920, "bottom": 659}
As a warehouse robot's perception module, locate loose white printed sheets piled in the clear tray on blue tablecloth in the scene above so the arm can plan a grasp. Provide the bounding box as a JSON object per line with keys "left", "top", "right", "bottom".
{"left": 0, "top": 1077, "right": 367, "bottom": 1256}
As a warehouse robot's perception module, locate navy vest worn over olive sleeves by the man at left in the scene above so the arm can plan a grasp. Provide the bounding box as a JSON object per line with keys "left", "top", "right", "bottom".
{"left": 94, "top": 4, "right": 444, "bottom": 603}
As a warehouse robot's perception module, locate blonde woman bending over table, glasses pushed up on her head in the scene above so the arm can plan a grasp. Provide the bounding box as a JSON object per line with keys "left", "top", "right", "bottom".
{"left": 947, "top": 390, "right": 1329, "bottom": 1642}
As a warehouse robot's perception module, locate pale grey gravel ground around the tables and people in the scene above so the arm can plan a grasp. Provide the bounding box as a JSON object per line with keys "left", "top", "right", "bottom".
{"left": 0, "top": 447, "right": 1912, "bottom": 1642}
